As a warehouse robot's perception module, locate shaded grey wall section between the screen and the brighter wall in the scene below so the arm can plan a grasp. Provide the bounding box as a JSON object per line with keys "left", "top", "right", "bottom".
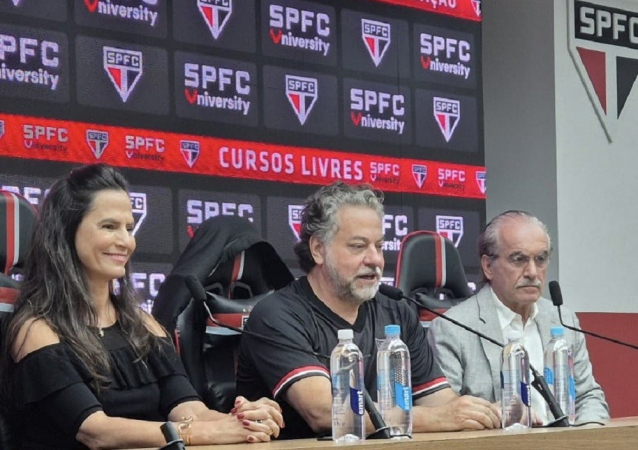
{"left": 482, "top": 0, "right": 561, "bottom": 294}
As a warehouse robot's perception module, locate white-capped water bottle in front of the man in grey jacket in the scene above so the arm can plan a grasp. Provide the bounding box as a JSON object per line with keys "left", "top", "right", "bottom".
{"left": 501, "top": 333, "right": 532, "bottom": 430}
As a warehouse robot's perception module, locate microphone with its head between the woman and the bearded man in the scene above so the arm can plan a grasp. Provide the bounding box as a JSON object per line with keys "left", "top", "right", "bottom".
{"left": 184, "top": 274, "right": 392, "bottom": 439}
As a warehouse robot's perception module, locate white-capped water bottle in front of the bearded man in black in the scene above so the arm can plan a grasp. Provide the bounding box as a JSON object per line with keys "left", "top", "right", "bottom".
{"left": 330, "top": 330, "right": 365, "bottom": 442}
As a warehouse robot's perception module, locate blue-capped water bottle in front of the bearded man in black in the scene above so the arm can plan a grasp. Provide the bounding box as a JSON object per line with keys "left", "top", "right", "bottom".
{"left": 377, "top": 325, "right": 412, "bottom": 436}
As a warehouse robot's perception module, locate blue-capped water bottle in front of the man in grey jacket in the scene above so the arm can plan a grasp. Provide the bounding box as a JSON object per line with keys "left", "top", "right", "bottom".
{"left": 544, "top": 327, "right": 576, "bottom": 425}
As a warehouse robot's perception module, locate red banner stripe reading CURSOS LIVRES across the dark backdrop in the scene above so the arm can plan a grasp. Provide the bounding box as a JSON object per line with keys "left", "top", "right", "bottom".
{"left": 0, "top": 115, "right": 485, "bottom": 199}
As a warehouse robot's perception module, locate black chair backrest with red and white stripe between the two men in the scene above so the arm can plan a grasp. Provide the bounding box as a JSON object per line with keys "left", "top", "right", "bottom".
{"left": 395, "top": 231, "right": 472, "bottom": 326}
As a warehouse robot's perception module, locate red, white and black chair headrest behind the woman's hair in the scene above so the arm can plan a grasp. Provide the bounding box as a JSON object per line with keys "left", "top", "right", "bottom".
{"left": 0, "top": 191, "right": 35, "bottom": 274}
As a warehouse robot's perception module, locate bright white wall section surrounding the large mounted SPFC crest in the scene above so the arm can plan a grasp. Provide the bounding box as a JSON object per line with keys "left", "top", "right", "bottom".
{"left": 554, "top": 1, "right": 638, "bottom": 312}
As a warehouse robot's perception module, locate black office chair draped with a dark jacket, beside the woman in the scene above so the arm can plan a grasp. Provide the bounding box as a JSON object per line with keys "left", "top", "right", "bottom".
{"left": 153, "top": 217, "right": 294, "bottom": 412}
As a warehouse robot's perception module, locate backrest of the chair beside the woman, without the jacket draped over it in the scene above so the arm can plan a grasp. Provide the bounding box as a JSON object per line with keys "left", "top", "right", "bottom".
{"left": 177, "top": 244, "right": 284, "bottom": 412}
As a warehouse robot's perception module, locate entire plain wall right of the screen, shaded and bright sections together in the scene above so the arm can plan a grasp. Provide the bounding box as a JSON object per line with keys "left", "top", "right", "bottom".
{"left": 483, "top": 0, "right": 638, "bottom": 312}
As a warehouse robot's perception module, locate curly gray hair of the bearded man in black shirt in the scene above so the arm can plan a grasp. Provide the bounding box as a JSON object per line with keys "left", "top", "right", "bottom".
{"left": 295, "top": 181, "right": 383, "bottom": 273}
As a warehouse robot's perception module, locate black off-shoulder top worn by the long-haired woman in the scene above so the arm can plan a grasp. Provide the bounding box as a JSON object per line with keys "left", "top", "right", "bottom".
{"left": 11, "top": 323, "right": 199, "bottom": 450}
